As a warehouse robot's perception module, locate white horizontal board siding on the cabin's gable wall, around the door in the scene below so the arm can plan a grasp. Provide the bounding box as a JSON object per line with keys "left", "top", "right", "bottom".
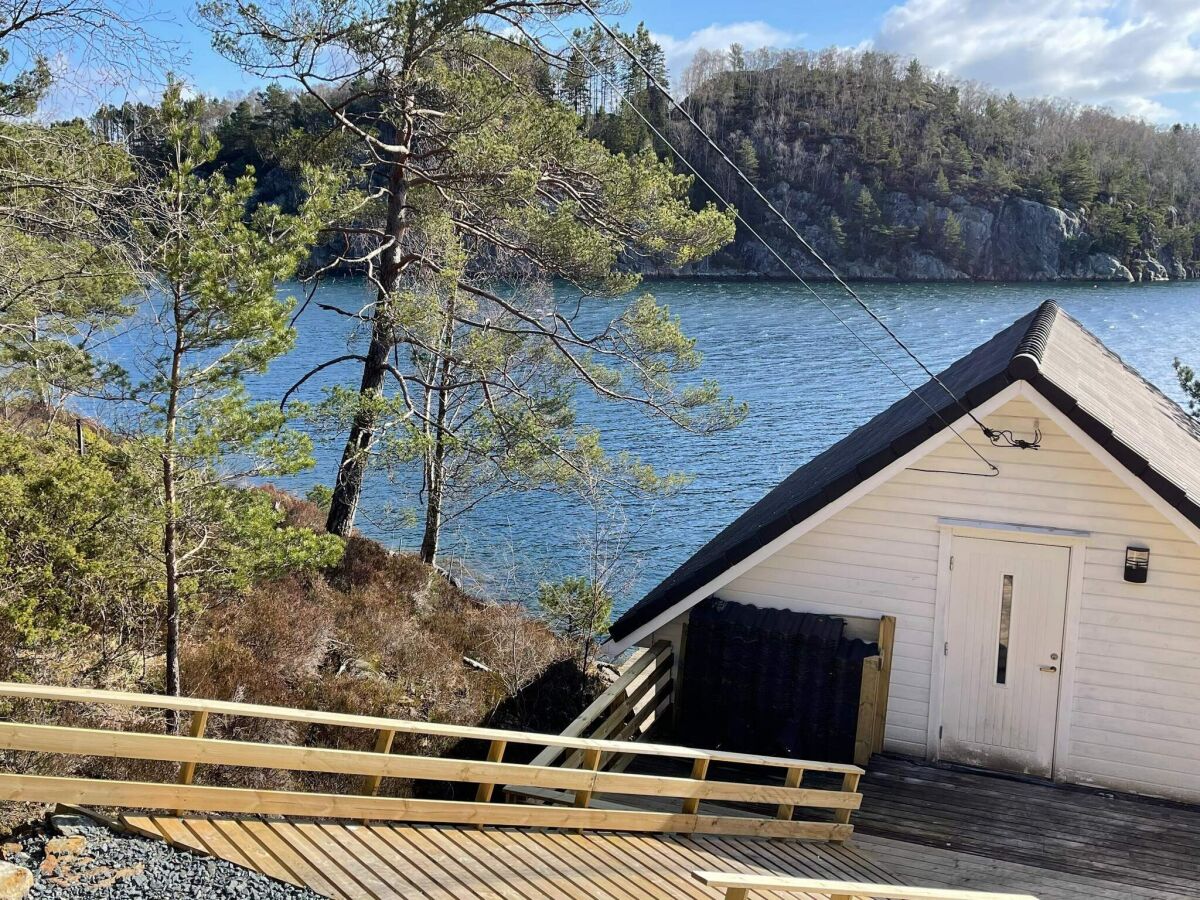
{"left": 718, "top": 400, "right": 1200, "bottom": 799}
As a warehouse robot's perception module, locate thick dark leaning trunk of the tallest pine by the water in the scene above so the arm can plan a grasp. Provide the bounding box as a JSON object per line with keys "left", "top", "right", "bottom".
{"left": 325, "top": 137, "right": 408, "bottom": 538}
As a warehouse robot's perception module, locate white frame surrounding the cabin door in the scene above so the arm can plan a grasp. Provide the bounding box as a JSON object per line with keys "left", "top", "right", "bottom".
{"left": 925, "top": 521, "right": 1091, "bottom": 781}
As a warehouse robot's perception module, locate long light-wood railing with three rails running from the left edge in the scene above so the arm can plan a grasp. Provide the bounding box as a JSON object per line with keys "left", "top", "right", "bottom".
{"left": 0, "top": 683, "right": 863, "bottom": 840}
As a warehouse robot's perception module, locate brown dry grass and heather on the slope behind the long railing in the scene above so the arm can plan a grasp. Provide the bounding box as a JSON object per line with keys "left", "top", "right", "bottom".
{"left": 0, "top": 491, "right": 593, "bottom": 823}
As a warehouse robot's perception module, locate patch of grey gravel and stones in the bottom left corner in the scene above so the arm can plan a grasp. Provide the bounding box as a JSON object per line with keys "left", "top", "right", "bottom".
{"left": 4, "top": 824, "right": 320, "bottom": 900}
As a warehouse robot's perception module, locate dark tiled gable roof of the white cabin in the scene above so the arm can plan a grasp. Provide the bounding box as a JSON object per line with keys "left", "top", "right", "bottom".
{"left": 610, "top": 300, "right": 1200, "bottom": 641}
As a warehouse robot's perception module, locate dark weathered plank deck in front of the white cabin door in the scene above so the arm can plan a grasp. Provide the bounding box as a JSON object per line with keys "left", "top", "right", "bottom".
{"left": 856, "top": 757, "right": 1200, "bottom": 900}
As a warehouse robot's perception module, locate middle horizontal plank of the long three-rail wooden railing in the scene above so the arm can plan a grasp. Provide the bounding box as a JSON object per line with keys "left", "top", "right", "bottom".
{"left": 0, "top": 722, "right": 846, "bottom": 808}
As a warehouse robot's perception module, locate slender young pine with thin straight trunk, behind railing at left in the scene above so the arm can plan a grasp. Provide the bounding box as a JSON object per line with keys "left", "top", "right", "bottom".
{"left": 133, "top": 82, "right": 335, "bottom": 710}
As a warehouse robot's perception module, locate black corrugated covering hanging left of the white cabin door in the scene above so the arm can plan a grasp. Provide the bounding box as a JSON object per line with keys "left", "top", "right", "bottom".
{"left": 678, "top": 598, "right": 878, "bottom": 762}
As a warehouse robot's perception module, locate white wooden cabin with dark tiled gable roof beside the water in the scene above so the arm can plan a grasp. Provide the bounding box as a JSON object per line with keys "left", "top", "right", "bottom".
{"left": 606, "top": 302, "right": 1200, "bottom": 802}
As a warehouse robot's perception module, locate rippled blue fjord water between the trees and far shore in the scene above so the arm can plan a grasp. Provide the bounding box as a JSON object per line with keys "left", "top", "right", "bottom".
{"left": 252, "top": 280, "right": 1200, "bottom": 608}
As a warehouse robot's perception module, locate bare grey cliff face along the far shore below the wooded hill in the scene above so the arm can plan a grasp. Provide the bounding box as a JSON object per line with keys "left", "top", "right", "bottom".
{"left": 681, "top": 193, "right": 1176, "bottom": 282}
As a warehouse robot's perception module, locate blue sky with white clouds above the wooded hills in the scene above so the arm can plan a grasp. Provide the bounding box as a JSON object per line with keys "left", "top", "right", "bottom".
{"left": 131, "top": 0, "right": 1200, "bottom": 124}
